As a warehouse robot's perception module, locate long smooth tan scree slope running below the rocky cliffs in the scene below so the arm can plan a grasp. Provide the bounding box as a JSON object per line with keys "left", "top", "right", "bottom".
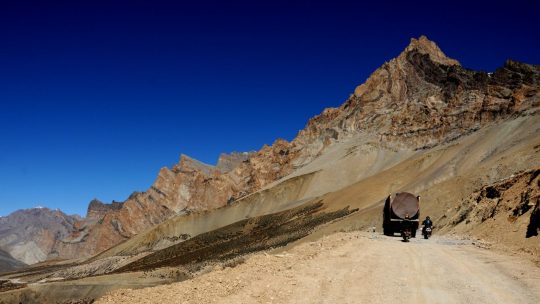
{"left": 93, "top": 115, "right": 540, "bottom": 260}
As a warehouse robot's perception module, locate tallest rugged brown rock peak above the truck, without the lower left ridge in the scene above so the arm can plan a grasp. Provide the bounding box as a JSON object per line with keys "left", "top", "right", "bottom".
{"left": 295, "top": 36, "right": 540, "bottom": 154}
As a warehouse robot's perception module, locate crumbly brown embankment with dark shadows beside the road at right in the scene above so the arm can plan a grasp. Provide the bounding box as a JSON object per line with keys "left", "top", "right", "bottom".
{"left": 439, "top": 167, "right": 540, "bottom": 249}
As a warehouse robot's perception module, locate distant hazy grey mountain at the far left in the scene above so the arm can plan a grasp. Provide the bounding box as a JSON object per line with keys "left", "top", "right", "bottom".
{"left": 0, "top": 207, "right": 80, "bottom": 264}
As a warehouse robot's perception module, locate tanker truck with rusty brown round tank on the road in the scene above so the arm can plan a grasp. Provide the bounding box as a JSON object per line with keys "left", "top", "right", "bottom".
{"left": 383, "top": 192, "right": 420, "bottom": 237}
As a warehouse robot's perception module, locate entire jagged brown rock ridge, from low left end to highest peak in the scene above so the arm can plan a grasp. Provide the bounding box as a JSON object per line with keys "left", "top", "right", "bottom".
{"left": 14, "top": 37, "right": 540, "bottom": 258}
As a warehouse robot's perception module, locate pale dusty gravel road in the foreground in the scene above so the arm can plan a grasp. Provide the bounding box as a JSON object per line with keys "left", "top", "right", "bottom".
{"left": 97, "top": 232, "right": 540, "bottom": 304}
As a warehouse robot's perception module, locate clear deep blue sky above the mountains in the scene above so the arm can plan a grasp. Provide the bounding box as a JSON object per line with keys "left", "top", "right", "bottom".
{"left": 0, "top": 0, "right": 540, "bottom": 215}
